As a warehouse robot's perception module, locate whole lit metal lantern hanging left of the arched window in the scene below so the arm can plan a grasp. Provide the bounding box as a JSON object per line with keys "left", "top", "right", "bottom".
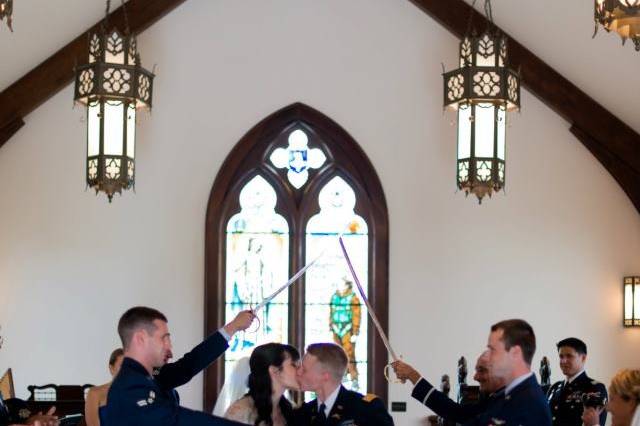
{"left": 74, "top": 1, "right": 154, "bottom": 202}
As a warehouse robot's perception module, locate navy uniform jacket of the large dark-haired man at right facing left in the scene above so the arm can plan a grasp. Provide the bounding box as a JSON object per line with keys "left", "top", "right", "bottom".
{"left": 465, "top": 375, "right": 551, "bottom": 426}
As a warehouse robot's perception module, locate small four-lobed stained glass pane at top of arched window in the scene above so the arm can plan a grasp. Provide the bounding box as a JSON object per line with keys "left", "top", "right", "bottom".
{"left": 269, "top": 129, "right": 327, "bottom": 189}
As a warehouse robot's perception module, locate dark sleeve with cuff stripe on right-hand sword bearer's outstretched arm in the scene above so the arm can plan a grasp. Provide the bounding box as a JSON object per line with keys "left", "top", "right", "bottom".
{"left": 411, "top": 378, "right": 504, "bottom": 424}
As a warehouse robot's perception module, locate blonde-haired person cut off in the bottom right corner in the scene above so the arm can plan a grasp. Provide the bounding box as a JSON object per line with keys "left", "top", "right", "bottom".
{"left": 582, "top": 370, "right": 640, "bottom": 426}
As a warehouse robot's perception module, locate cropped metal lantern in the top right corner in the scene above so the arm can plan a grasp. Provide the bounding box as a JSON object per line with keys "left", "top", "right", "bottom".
{"left": 593, "top": 0, "right": 640, "bottom": 51}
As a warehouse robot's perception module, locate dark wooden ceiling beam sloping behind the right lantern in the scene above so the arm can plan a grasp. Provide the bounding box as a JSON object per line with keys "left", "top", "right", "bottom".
{"left": 410, "top": 0, "right": 640, "bottom": 211}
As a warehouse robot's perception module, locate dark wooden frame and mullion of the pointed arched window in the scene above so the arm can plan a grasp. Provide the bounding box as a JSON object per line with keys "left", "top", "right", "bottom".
{"left": 204, "top": 103, "right": 389, "bottom": 411}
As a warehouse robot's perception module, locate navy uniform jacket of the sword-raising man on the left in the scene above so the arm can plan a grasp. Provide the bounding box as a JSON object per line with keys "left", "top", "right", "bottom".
{"left": 100, "top": 332, "right": 240, "bottom": 426}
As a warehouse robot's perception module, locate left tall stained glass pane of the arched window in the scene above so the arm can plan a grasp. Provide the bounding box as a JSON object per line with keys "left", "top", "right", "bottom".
{"left": 225, "top": 176, "right": 289, "bottom": 375}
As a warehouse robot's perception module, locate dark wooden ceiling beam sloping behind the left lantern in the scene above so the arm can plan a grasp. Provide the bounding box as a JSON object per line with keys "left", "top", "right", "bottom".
{"left": 0, "top": 0, "right": 185, "bottom": 147}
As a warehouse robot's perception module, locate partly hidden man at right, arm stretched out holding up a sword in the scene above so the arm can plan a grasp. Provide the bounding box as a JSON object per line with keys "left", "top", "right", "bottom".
{"left": 392, "top": 354, "right": 504, "bottom": 423}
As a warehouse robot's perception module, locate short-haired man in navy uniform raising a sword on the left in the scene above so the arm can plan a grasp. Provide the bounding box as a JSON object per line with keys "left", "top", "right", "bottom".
{"left": 100, "top": 306, "right": 255, "bottom": 426}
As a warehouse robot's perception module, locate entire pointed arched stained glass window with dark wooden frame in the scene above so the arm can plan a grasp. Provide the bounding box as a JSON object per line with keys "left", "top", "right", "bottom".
{"left": 204, "top": 104, "right": 388, "bottom": 410}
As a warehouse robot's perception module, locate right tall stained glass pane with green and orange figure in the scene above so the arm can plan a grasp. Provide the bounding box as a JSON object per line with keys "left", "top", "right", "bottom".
{"left": 305, "top": 177, "right": 369, "bottom": 392}
